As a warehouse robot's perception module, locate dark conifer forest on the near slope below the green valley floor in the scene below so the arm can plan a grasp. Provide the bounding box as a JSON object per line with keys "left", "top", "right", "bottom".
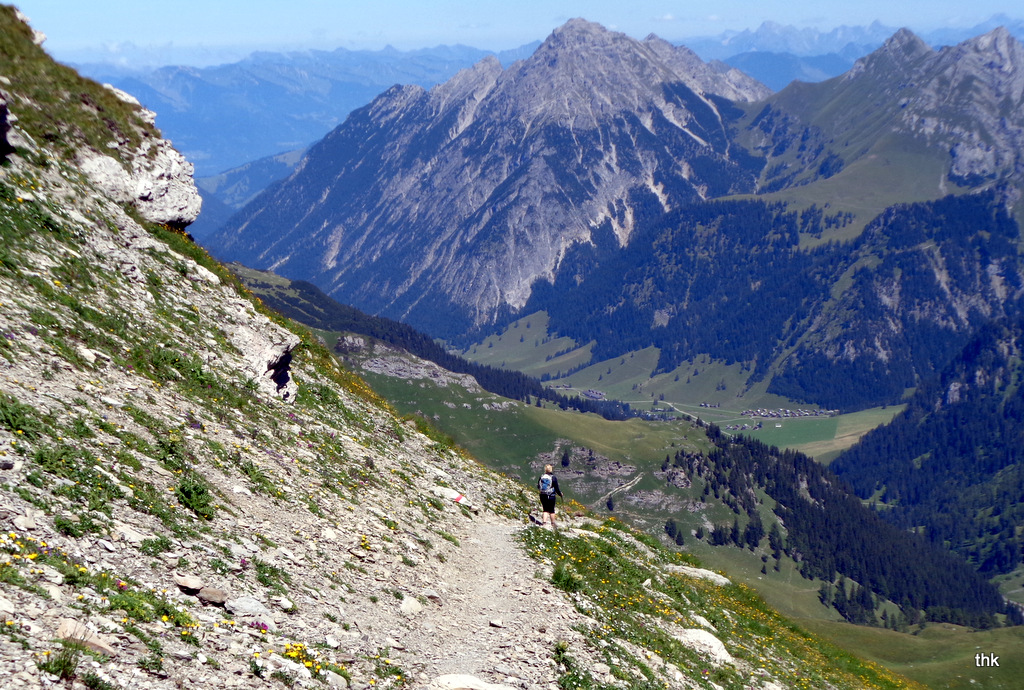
{"left": 674, "top": 426, "right": 1021, "bottom": 628}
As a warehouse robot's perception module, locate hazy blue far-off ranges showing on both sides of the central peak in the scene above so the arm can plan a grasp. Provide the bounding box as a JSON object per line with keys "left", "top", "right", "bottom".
{"left": 75, "top": 16, "right": 1024, "bottom": 204}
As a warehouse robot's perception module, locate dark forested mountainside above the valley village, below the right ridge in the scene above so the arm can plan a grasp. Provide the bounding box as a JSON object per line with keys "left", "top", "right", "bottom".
{"left": 524, "top": 193, "right": 1024, "bottom": 411}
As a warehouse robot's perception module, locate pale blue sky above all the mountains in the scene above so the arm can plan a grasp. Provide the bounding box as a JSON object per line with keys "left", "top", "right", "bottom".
{"left": 6, "top": 0, "right": 1024, "bottom": 63}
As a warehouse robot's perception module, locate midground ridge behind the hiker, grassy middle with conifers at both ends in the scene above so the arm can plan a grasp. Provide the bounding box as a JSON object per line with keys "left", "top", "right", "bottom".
{"left": 230, "top": 264, "right": 1002, "bottom": 628}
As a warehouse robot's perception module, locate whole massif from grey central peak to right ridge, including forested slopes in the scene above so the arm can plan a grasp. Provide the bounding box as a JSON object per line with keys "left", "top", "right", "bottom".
{"left": 203, "top": 20, "right": 1024, "bottom": 409}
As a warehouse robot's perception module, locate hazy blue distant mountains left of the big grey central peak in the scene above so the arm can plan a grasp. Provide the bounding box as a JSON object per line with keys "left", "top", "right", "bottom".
{"left": 81, "top": 44, "right": 536, "bottom": 177}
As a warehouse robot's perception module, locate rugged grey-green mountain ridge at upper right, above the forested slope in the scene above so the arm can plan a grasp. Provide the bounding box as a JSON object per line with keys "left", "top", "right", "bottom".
{"left": 751, "top": 28, "right": 1024, "bottom": 193}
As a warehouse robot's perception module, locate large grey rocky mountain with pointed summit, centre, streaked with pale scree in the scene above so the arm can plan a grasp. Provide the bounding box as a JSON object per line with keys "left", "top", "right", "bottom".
{"left": 210, "top": 19, "right": 768, "bottom": 331}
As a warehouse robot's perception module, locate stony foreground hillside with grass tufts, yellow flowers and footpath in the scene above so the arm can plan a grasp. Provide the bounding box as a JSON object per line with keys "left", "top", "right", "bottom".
{"left": 0, "top": 6, "right": 925, "bottom": 690}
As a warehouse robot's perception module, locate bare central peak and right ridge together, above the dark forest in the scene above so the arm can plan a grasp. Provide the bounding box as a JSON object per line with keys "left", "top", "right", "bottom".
{"left": 210, "top": 25, "right": 1024, "bottom": 343}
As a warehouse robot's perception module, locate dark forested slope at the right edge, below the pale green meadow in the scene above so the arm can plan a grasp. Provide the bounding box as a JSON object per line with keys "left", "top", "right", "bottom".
{"left": 833, "top": 316, "right": 1024, "bottom": 575}
